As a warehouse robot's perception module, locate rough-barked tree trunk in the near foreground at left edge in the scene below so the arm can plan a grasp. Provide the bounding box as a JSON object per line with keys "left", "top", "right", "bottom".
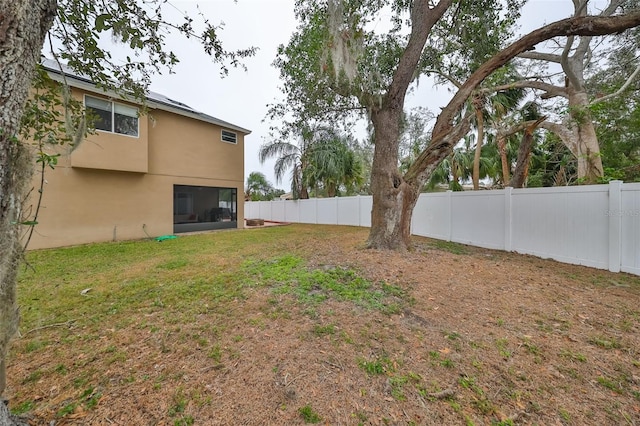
{"left": 0, "top": 0, "right": 56, "bottom": 416}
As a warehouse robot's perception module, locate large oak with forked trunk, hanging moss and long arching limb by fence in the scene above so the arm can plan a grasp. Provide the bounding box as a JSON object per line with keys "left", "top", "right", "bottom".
{"left": 271, "top": 0, "right": 640, "bottom": 250}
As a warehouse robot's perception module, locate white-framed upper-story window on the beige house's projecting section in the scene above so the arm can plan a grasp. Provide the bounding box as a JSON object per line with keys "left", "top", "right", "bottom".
{"left": 84, "top": 95, "right": 138, "bottom": 137}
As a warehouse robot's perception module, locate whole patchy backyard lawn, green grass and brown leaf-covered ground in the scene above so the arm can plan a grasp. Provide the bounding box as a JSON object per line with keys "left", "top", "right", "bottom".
{"left": 5, "top": 225, "right": 640, "bottom": 425}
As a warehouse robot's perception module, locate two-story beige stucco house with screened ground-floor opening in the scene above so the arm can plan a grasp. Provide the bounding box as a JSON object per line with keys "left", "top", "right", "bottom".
{"left": 29, "top": 61, "right": 250, "bottom": 249}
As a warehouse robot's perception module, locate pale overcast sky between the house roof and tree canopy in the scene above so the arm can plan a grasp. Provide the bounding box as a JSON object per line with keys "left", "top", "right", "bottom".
{"left": 151, "top": 0, "right": 596, "bottom": 191}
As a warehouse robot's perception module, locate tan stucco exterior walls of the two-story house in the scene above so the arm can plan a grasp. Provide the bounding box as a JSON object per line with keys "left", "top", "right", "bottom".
{"left": 29, "top": 85, "right": 244, "bottom": 249}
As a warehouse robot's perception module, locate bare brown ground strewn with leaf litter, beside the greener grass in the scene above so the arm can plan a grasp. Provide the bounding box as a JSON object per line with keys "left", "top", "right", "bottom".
{"left": 7, "top": 225, "right": 640, "bottom": 425}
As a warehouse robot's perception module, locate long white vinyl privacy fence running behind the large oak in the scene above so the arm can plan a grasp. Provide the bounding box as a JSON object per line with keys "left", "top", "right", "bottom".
{"left": 245, "top": 181, "right": 640, "bottom": 275}
